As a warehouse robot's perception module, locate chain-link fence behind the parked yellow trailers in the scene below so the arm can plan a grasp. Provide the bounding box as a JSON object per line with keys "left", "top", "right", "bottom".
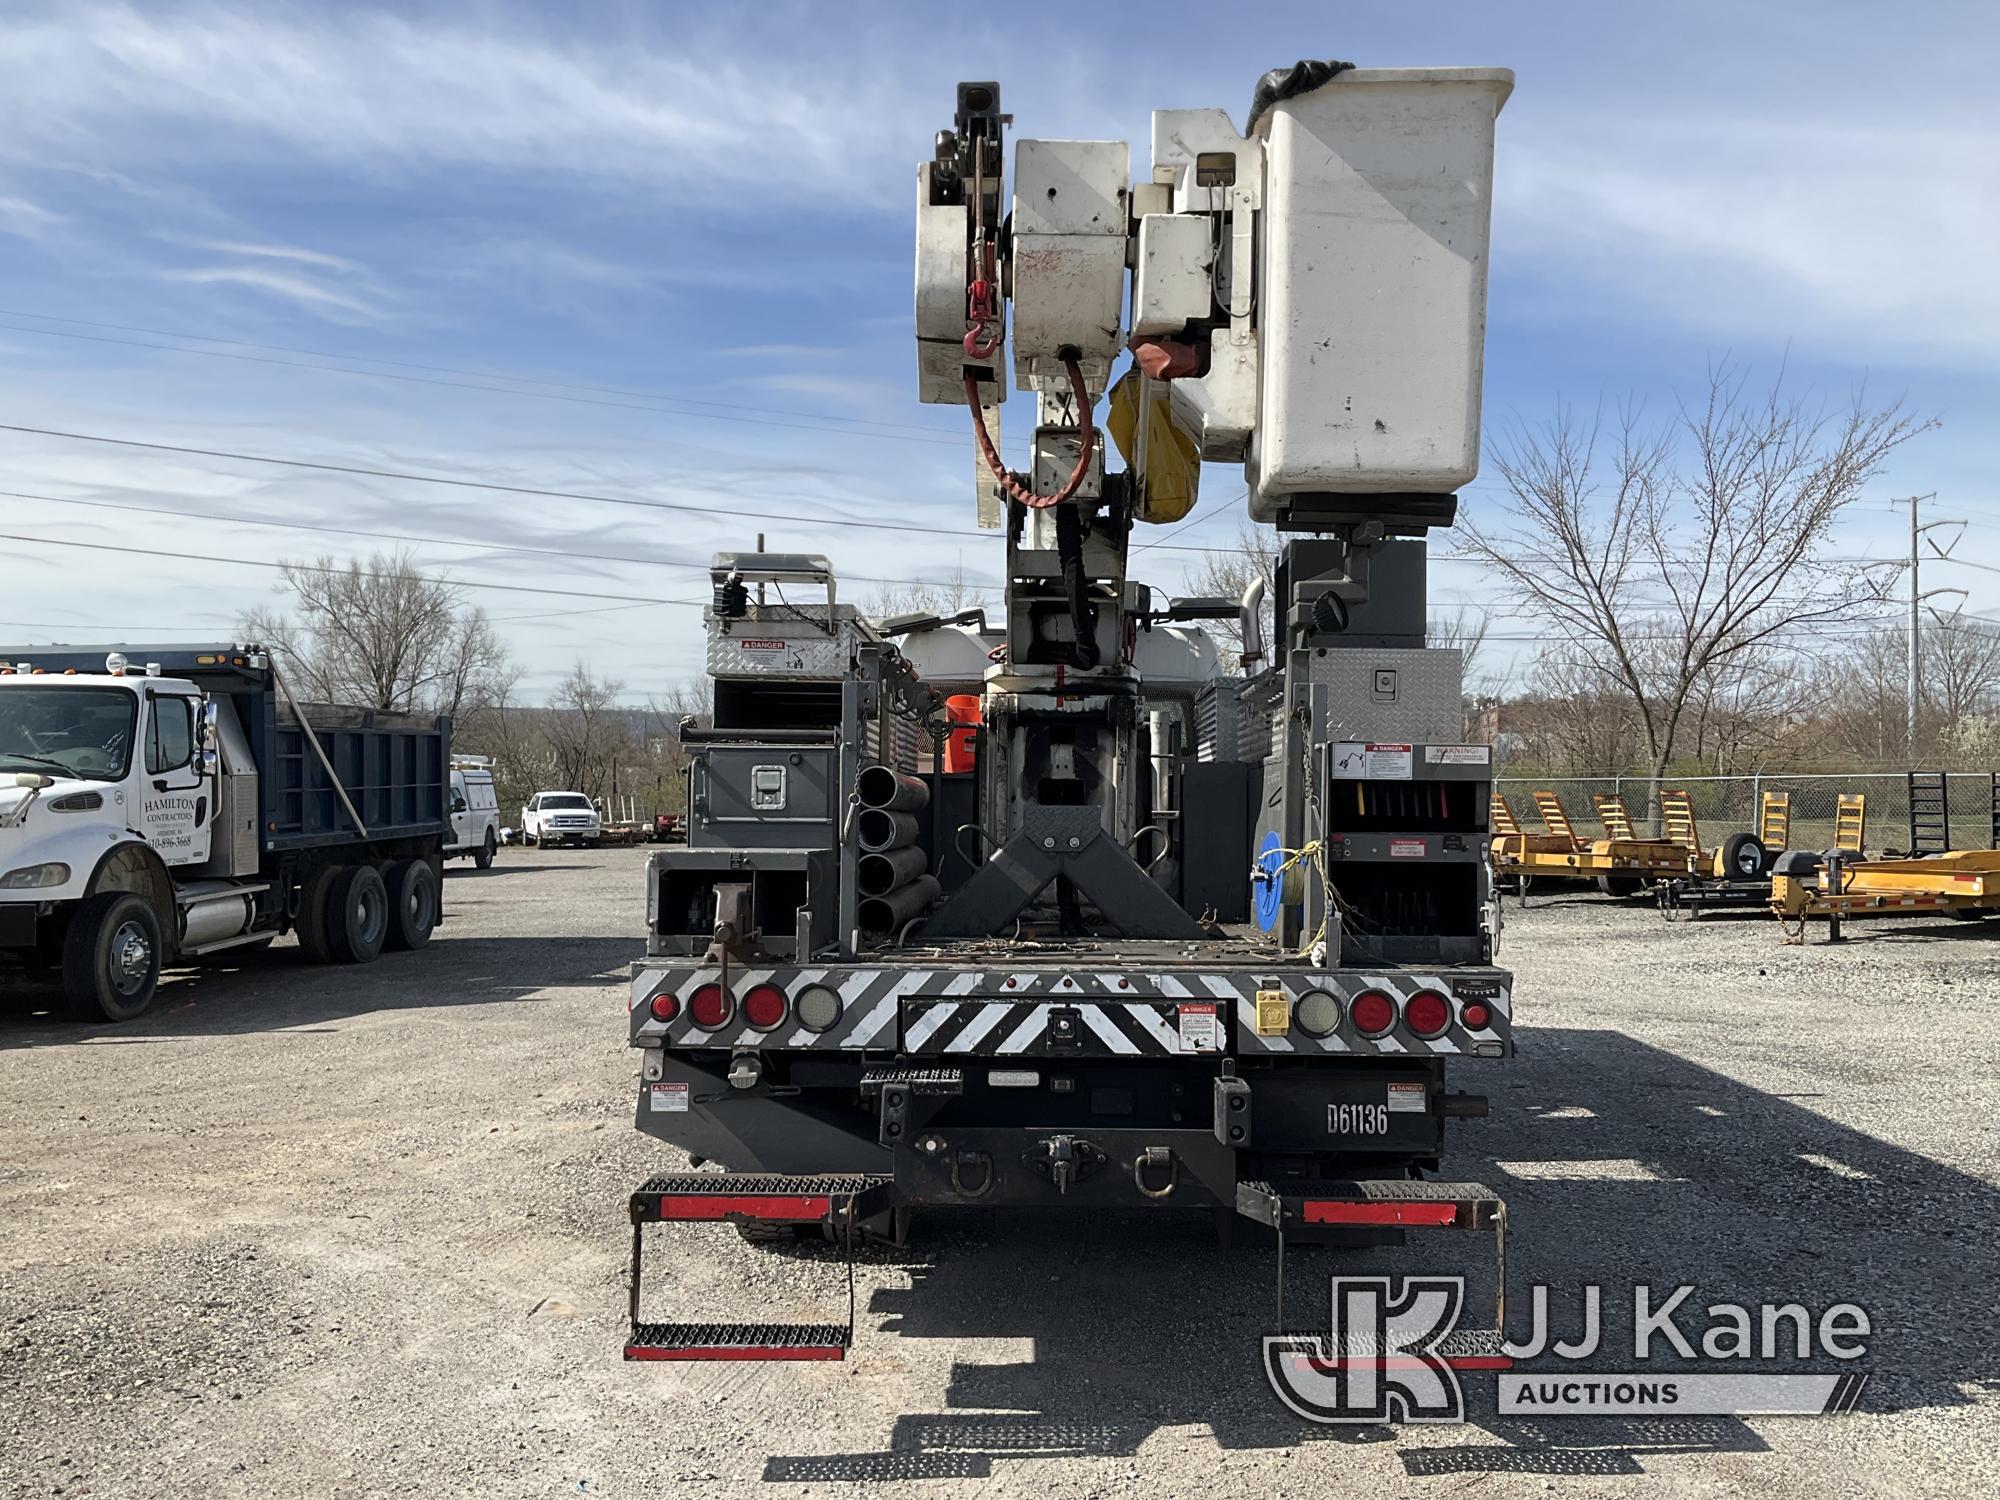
{"left": 1494, "top": 770, "right": 2000, "bottom": 852}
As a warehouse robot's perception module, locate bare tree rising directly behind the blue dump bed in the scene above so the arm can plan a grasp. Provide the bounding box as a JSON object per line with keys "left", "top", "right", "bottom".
{"left": 242, "top": 552, "right": 512, "bottom": 718}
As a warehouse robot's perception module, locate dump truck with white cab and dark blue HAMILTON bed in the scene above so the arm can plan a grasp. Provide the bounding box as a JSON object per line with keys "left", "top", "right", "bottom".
{"left": 0, "top": 644, "right": 450, "bottom": 1020}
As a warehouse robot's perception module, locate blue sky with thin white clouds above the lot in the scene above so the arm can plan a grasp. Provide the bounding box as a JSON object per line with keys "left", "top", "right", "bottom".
{"left": 0, "top": 4, "right": 2000, "bottom": 700}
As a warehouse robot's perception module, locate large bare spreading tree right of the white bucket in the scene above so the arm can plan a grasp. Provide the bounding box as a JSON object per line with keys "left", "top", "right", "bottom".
{"left": 1460, "top": 364, "right": 1934, "bottom": 780}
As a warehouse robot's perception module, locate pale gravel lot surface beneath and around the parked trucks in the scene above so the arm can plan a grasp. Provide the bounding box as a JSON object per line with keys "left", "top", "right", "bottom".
{"left": 0, "top": 850, "right": 2000, "bottom": 1500}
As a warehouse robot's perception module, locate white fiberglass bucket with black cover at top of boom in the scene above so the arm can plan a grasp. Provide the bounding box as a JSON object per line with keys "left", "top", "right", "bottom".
{"left": 1250, "top": 68, "right": 1514, "bottom": 502}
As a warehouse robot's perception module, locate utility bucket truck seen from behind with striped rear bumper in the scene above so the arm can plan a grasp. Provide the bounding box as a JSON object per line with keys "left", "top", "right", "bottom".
{"left": 626, "top": 64, "right": 1514, "bottom": 1360}
